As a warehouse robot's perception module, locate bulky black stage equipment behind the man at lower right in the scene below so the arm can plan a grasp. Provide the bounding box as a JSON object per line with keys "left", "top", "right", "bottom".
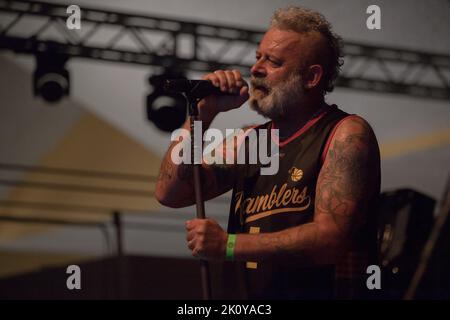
{"left": 378, "top": 189, "right": 435, "bottom": 299}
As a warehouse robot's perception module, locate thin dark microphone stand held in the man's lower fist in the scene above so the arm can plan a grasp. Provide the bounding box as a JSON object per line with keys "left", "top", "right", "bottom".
{"left": 185, "top": 92, "right": 211, "bottom": 300}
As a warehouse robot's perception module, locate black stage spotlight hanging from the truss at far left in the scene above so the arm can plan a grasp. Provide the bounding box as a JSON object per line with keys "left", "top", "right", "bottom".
{"left": 33, "top": 53, "right": 70, "bottom": 103}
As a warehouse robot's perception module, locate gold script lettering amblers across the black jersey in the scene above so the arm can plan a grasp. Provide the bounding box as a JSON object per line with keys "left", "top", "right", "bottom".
{"left": 234, "top": 183, "right": 311, "bottom": 222}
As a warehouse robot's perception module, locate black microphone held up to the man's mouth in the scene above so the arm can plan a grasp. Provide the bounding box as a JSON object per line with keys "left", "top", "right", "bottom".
{"left": 164, "top": 79, "right": 239, "bottom": 99}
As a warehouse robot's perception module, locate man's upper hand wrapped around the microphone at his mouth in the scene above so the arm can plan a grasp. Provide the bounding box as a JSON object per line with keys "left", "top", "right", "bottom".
{"left": 198, "top": 70, "right": 249, "bottom": 120}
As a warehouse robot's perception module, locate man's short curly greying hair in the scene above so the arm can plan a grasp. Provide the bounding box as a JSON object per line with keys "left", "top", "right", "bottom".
{"left": 270, "top": 6, "right": 344, "bottom": 92}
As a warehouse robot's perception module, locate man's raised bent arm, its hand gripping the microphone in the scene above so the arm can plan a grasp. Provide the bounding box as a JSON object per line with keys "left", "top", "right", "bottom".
{"left": 155, "top": 70, "right": 249, "bottom": 208}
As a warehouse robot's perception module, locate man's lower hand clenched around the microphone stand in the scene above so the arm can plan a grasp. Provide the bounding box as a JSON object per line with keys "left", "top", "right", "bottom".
{"left": 186, "top": 219, "right": 228, "bottom": 260}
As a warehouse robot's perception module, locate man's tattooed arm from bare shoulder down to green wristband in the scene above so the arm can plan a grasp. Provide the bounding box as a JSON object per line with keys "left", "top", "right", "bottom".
{"left": 191, "top": 116, "right": 380, "bottom": 266}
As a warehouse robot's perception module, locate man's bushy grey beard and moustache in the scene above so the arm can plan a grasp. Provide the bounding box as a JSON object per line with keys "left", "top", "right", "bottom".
{"left": 249, "top": 72, "right": 305, "bottom": 120}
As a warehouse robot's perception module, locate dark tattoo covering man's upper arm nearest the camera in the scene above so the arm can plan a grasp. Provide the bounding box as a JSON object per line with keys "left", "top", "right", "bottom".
{"left": 316, "top": 119, "right": 377, "bottom": 232}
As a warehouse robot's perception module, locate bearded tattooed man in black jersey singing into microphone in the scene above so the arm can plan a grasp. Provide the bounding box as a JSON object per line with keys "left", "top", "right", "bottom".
{"left": 156, "top": 7, "right": 380, "bottom": 299}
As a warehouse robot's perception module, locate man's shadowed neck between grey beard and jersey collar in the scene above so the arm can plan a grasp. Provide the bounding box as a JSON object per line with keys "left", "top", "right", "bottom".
{"left": 273, "top": 97, "right": 325, "bottom": 139}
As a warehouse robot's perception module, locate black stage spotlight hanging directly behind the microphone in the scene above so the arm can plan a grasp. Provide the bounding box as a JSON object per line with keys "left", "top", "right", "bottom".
{"left": 147, "top": 71, "right": 187, "bottom": 132}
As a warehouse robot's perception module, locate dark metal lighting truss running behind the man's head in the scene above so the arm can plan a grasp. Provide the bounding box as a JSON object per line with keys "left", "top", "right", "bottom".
{"left": 0, "top": 0, "right": 450, "bottom": 99}
